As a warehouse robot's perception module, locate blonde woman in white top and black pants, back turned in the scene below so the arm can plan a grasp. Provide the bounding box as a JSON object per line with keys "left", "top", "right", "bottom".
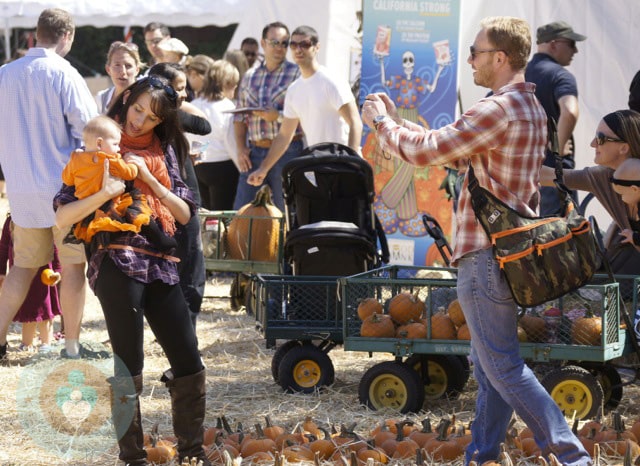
{"left": 190, "top": 60, "right": 240, "bottom": 210}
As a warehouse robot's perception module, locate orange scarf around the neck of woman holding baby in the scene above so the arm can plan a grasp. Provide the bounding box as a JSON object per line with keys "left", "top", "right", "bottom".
{"left": 120, "top": 131, "right": 176, "bottom": 236}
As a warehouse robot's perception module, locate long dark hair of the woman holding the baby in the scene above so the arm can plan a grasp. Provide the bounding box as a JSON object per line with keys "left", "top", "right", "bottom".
{"left": 107, "top": 76, "right": 189, "bottom": 170}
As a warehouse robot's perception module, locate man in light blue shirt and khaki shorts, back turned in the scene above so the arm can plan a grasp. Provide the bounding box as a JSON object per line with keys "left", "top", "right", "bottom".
{"left": 0, "top": 8, "right": 97, "bottom": 359}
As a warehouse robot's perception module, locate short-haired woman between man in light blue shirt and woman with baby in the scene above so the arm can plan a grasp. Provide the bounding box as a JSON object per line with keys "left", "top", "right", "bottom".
{"left": 95, "top": 41, "right": 144, "bottom": 113}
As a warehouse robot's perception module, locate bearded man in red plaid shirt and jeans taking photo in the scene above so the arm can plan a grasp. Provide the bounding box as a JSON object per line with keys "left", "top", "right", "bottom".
{"left": 362, "top": 17, "right": 591, "bottom": 465}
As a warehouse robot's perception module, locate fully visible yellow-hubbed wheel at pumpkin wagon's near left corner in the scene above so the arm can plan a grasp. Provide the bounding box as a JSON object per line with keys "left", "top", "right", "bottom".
{"left": 358, "top": 361, "right": 424, "bottom": 413}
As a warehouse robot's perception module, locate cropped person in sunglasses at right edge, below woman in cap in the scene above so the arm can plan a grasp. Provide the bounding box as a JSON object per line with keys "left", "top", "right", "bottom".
{"left": 611, "top": 159, "right": 640, "bottom": 246}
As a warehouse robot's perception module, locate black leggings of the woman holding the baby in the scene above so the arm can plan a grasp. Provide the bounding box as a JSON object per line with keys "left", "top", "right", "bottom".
{"left": 95, "top": 257, "right": 202, "bottom": 378}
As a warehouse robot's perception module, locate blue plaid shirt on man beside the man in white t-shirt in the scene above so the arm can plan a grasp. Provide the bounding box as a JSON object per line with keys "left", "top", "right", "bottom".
{"left": 234, "top": 60, "right": 303, "bottom": 141}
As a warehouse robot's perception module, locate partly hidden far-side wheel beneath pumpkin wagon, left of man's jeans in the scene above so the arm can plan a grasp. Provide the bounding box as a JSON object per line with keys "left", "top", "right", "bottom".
{"left": 405, "top": 354, "right": 469, "bottom": 400}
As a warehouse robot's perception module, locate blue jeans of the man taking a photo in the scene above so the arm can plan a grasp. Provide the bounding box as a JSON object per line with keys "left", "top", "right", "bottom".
{"left": 458, "top": 249, "right": 592, "bottom": 466}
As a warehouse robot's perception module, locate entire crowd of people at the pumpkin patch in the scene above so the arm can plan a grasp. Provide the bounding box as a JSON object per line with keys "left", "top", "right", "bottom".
{"left": 0, "top": 8, "right": 640, "bottom": 466}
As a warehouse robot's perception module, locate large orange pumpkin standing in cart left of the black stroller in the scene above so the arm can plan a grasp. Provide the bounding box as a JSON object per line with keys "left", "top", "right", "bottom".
{"left": 226, "top": 185, "right": 282, "bottom": 262}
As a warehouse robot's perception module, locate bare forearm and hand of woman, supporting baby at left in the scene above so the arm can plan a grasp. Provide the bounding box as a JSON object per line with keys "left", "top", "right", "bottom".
{"left": 56, "top": 159, "right": 125, "bottom": 229}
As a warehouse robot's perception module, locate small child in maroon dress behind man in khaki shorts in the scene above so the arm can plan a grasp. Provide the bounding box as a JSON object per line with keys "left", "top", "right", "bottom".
{"left": 0, "top": 215, "right": 60, "bottom": 352}
